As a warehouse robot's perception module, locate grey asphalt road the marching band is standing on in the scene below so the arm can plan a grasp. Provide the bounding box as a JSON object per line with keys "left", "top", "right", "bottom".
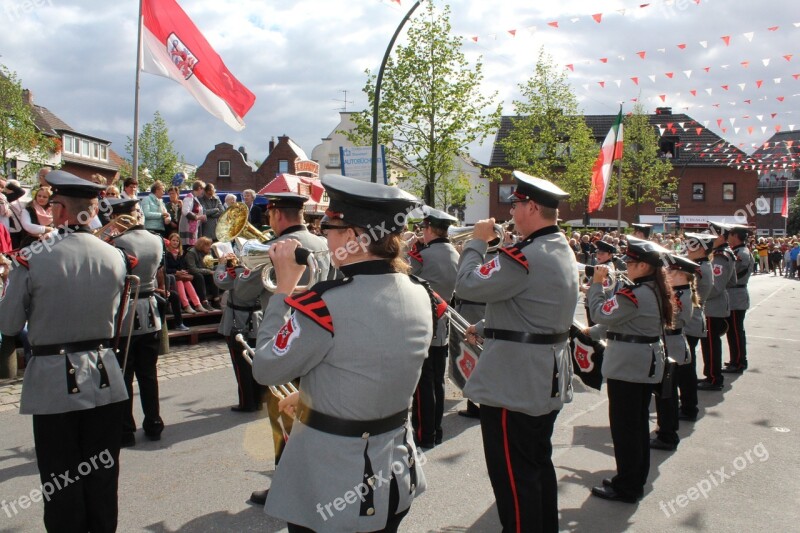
{"left": 0, "top": 276, "right": 800, "bottom": 533}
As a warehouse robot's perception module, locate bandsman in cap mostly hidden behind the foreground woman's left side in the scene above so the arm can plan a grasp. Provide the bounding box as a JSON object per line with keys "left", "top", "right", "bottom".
{"left": 239, "top": 192, "right": 330, "bottom": 505}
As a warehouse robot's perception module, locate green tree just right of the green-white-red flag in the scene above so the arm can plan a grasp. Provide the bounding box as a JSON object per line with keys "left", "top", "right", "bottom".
{"left": 605, "top": 103, "right": 678, "bottom": 220}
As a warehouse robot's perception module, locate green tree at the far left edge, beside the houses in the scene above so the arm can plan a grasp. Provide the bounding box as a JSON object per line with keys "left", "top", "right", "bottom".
{"left": 0, "top": 65, "right": 60, "bottom": 180}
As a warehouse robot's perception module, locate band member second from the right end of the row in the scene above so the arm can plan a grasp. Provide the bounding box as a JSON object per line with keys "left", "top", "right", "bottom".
{"left": 697, "top": 222, "right": 736, "bottom": 391}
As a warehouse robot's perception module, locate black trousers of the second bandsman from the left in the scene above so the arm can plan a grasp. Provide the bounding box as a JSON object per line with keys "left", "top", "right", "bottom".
{"left": 118, "top": 331, "right": 164, "bottom": 436}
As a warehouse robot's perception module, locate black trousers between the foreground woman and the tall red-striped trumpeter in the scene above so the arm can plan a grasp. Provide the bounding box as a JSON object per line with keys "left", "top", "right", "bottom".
{"left": 411, "top": 346, "right": 449, "bottom": 448}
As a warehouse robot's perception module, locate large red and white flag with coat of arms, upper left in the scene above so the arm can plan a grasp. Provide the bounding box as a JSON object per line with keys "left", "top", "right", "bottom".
{"left": 139, "top": 0, "right": 256, "bottom": 131}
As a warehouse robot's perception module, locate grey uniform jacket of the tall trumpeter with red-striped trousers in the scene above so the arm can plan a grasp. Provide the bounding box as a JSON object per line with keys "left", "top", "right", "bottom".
{"left": 456, "top": 226, "right": 578, "bottom": 416}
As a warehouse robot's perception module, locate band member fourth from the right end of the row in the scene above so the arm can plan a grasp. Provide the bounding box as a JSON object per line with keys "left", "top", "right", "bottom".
{"left": 650, "top": 254, "right": 700, "bottom": 451}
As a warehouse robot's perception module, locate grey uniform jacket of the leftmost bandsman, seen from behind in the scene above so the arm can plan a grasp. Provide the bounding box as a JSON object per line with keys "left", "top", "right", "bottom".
{"left": 0, "top": 229, "right": 128, "bottom": 415}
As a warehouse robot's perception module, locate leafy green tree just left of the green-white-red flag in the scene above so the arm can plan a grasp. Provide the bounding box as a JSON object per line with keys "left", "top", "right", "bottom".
{"left": 498, "top": 50, "right": 597, "bottom": 204}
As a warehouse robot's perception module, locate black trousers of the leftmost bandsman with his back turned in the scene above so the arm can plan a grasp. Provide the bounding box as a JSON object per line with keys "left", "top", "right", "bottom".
{"left": 33, "top": 402, "right": 125, "bottom": 533}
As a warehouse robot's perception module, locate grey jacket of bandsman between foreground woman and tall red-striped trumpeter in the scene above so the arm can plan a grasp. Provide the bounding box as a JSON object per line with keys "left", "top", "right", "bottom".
{"left": 408, "top": 239, "right": 458, "bottom": 346}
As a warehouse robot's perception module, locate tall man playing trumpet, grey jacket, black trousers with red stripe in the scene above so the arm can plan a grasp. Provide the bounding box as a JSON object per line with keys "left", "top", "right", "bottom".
{"left": 456, "top": 171, "right": 578, "bottom": 531}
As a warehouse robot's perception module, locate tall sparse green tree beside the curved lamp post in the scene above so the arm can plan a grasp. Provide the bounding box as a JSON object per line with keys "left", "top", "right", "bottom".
{"left": 342, "top": 2, "right": 501, "bottom": 209}
